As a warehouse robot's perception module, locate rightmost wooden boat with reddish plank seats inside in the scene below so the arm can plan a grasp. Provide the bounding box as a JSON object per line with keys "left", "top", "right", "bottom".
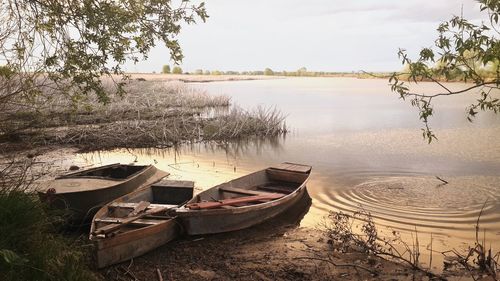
{"left": 175, "top": 163, "right": 311, "bottom": 235}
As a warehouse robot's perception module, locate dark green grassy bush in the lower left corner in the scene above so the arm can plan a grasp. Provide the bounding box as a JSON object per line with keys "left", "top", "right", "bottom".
{"left": 0, "top": 162, "right": 98, "bottom": 281}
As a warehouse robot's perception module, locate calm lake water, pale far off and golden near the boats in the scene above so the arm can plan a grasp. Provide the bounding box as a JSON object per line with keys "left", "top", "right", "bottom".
{"left": 78, "top": 78, "right": 500, "bottom": 266}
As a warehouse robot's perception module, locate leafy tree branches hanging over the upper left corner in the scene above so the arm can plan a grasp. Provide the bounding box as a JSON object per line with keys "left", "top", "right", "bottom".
{"left": 0, "top": 0, "right": 208, "bottom": 114}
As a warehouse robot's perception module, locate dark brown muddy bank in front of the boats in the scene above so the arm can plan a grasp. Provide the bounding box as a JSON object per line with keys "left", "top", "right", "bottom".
{"left": 100, "top": 226, "right": 430, "bottom": 280}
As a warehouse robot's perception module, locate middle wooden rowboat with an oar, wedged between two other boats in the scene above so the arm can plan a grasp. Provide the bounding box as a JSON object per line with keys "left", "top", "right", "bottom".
{"left": 89, "top": 180, "right": 194, "bottom": 268}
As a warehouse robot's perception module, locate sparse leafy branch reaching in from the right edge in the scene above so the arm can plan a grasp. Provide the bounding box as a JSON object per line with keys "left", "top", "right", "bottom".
{"left": 389, "top": 0, "right": 500, "bottom": 143}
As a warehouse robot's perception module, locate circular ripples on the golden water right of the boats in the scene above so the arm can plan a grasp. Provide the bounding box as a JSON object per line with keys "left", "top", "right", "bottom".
{"left": 317, "top": 176, "right": 500, "bottom": 233}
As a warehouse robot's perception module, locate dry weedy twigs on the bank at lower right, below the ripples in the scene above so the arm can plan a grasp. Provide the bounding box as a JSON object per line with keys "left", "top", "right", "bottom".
{"left": 323, "top": 207, "right": 500, "bottom": 280}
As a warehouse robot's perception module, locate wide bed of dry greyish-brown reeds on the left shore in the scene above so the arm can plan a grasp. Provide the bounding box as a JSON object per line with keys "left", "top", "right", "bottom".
{"left": 0, "top": 80, "right": 286, "bottom": 150}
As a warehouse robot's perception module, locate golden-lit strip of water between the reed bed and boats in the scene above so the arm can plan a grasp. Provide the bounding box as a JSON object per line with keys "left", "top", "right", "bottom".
{"left": 77, "top": 137, "right": 285, "bottom": 191}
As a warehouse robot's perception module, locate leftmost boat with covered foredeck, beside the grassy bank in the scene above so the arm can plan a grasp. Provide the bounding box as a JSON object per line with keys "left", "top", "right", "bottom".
{"left": 38, "top": 164, "right": 169, "bottom": 222}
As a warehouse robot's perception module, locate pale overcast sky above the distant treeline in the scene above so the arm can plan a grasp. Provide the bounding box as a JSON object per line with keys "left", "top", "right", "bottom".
{"left": 125, "top": 0, "right": 486, "bottom": 72}
